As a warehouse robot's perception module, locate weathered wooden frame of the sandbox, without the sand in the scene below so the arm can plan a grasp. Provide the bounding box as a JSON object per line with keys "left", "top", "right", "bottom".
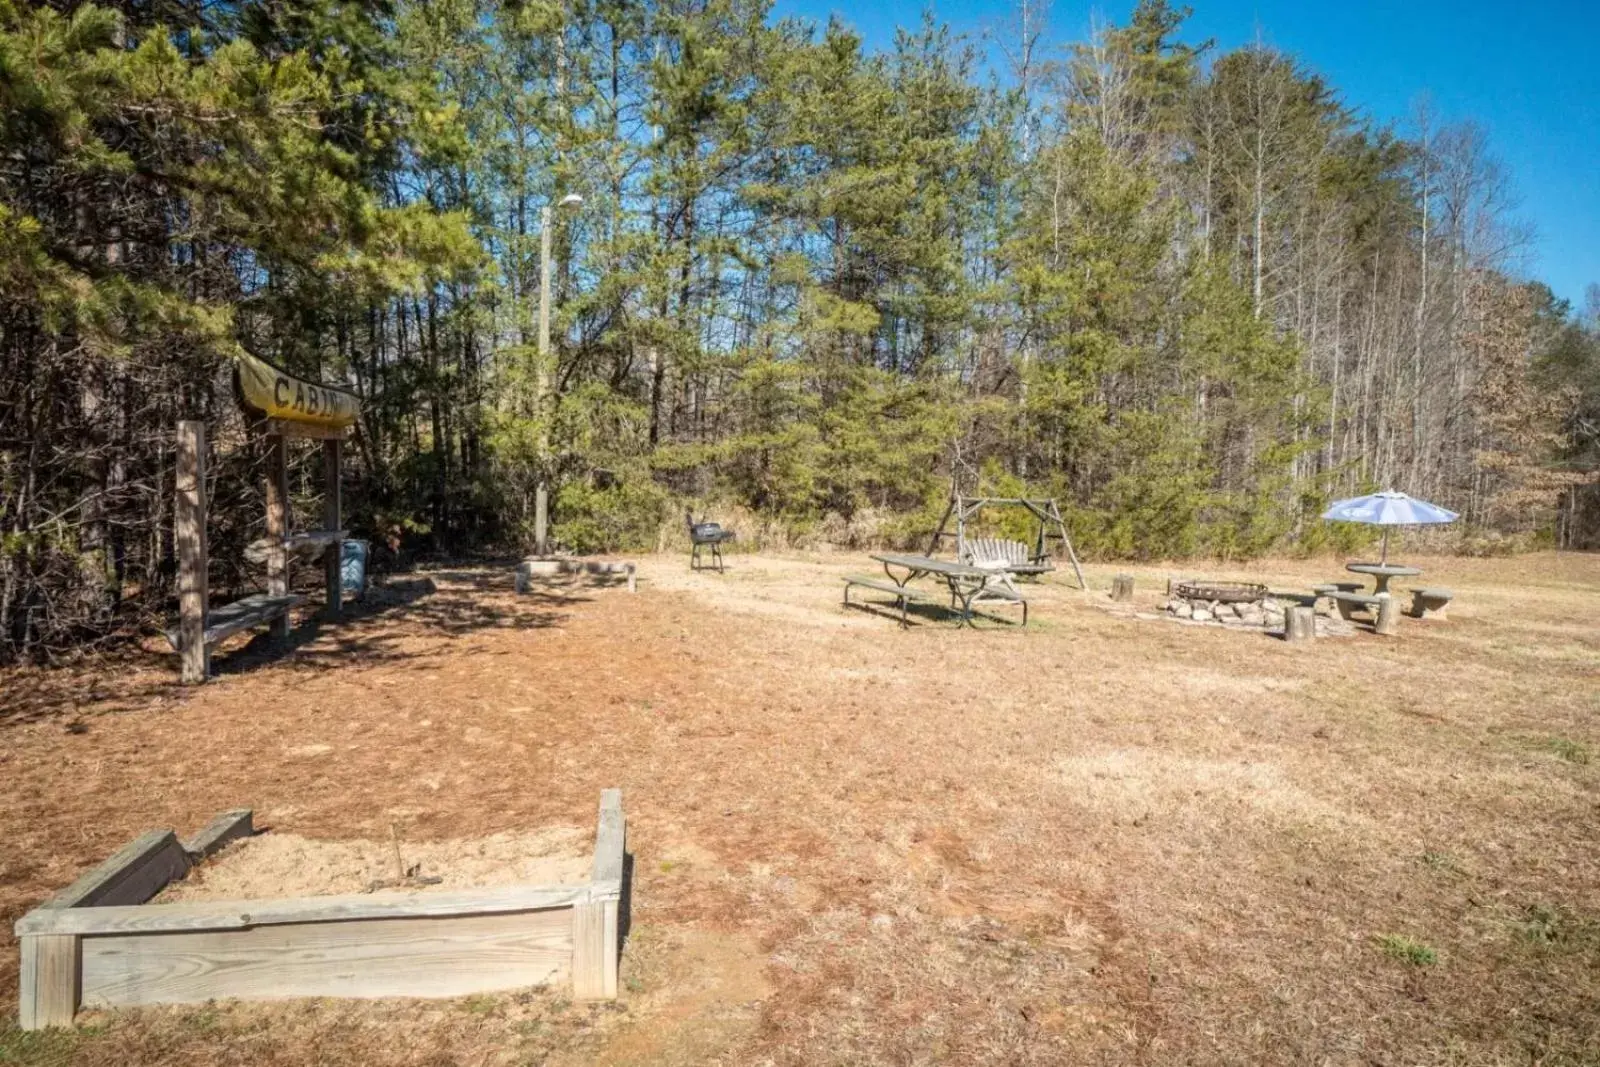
{"left": 14, "top": 789, "right": 627, "bottom": 1030}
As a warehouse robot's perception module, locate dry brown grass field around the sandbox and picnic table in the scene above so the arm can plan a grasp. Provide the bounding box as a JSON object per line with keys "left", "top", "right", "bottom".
{"left": 0, "top": 555, "right": 1600, "bottom": 1067}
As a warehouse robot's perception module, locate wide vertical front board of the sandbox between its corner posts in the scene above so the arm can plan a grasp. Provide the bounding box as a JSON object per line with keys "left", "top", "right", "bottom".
{"left": 83, "top": 907, "right": 573, "bottom": 1008}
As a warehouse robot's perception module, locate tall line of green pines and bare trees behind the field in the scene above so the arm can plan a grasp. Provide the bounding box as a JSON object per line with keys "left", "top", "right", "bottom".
{"left": 0, "top": 0, "right": 1600, "bottom": 657}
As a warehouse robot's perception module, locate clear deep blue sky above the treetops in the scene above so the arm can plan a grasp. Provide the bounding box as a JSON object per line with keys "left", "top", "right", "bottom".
{"left": 776, "top": 0, "right": 1600, "bottom": 307}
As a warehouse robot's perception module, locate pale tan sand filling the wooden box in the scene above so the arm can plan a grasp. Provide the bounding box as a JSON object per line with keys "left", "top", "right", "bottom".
{"left": 154, "top": 827, "right": 594, "bottom": 904}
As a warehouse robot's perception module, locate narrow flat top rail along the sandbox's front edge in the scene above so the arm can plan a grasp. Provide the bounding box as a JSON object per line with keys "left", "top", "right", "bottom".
{"left": 16, "top": 885, "right": 592, "bottom": 934}
